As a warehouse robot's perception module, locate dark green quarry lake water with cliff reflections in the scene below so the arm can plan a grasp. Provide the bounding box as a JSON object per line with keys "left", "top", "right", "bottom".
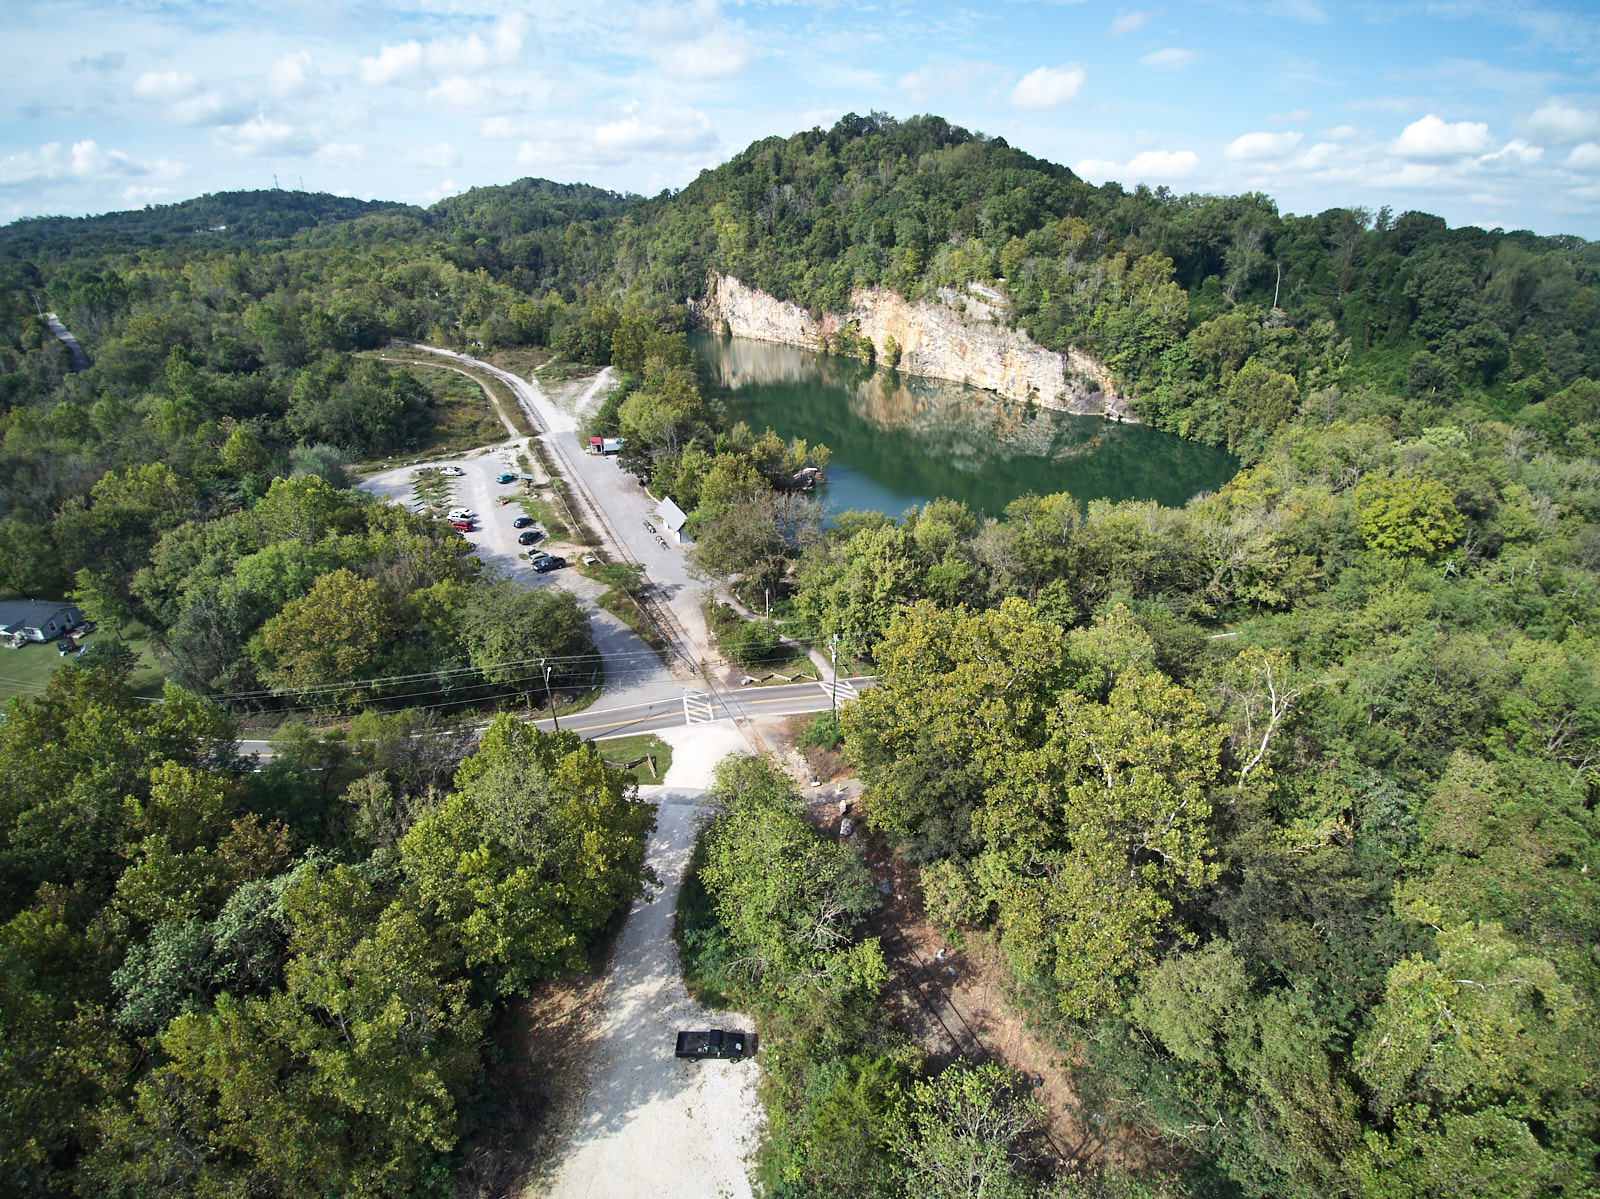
{"left": 694, "top": 335, "right": 1238, "bottom": 515}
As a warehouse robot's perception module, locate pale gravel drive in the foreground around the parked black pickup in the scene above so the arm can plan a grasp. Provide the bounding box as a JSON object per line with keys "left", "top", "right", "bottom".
{"left": 540, "top": 725, "right": 760, "bottom": 1199}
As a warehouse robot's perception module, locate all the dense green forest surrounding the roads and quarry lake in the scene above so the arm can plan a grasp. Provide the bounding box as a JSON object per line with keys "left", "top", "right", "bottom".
{"left": 0, "top": 115, "right": 1600, "bottom": 1199}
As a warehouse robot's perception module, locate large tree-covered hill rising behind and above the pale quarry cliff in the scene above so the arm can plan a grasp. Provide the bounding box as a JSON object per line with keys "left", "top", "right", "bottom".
{"left": 435, "top": 114, "right": 1600, "bottom": 459}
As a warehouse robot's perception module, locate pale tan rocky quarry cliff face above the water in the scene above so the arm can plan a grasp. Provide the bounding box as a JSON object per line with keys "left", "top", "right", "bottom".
{"left": 699, "top": 275, "right": 1138, "bottom": 421}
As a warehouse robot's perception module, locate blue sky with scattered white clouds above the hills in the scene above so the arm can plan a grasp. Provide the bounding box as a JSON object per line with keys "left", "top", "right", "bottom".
{"left": 0, "top": 0, "right": 1600, "bottom": 239}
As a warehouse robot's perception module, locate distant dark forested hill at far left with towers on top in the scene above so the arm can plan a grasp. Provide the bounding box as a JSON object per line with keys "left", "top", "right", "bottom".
{"left": 0, "top": 189, "right": 406, "bottom": 259}
